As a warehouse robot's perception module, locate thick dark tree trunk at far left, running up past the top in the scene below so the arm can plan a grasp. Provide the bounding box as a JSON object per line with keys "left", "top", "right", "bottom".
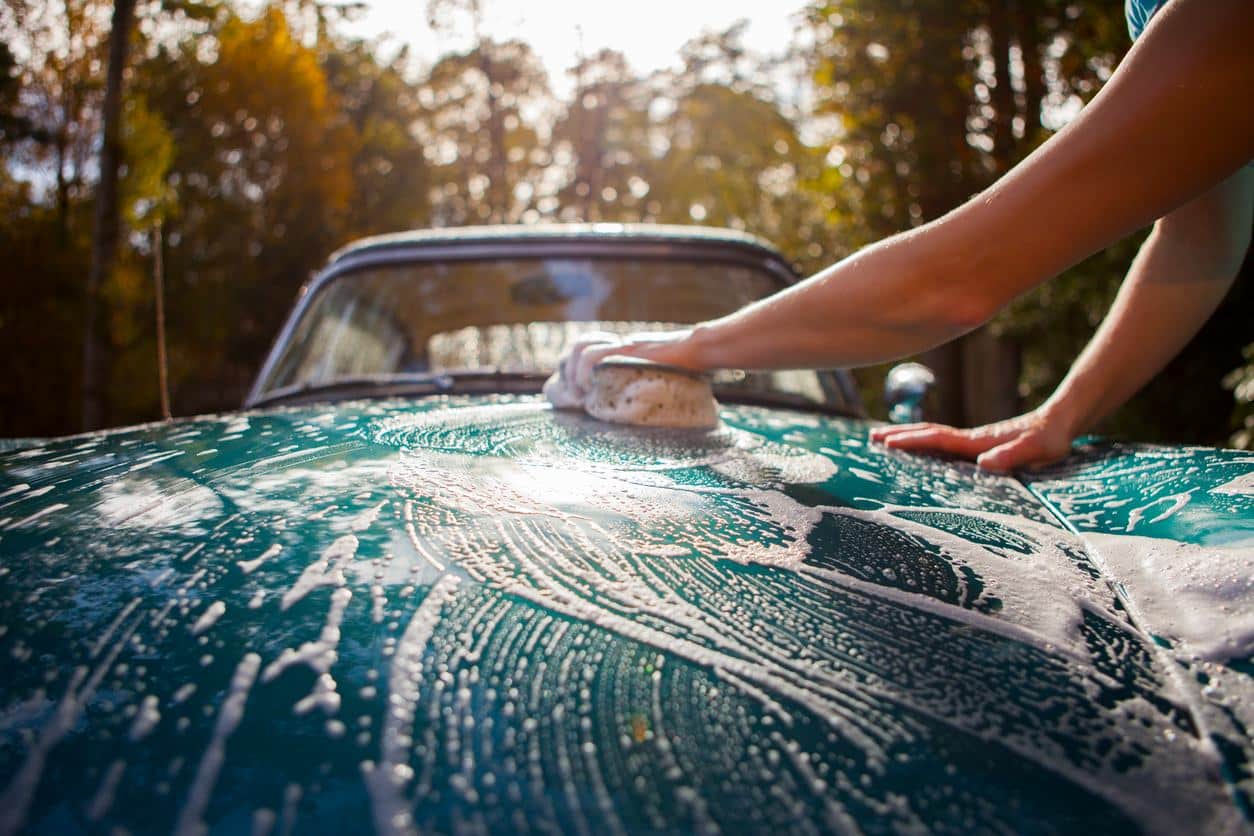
{"left": 83, "top": 0, "right": 135, "bottom": 430}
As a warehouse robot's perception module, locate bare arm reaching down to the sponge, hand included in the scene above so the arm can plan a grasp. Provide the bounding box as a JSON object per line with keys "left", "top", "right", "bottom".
{"left": 574, "top": 0, "right": 1254, "bottom": 381}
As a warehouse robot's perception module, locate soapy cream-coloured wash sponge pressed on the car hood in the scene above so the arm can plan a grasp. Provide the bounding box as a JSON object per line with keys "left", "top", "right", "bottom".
{"left": 544, "top": 357, "right": 719, "bottom": 429}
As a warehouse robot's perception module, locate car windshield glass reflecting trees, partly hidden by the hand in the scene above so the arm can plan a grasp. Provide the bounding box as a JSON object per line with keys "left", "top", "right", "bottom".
{"left": 260, "top": 256, "right": 848, "bottom": 407}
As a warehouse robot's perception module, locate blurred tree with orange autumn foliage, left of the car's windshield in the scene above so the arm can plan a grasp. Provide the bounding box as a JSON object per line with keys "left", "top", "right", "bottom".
{"left": 139, "top": 9, "right": 357, "bottom": 411}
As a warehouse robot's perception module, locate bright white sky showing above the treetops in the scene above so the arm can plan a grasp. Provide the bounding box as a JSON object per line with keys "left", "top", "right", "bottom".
{"left": 350, "top": 0, "right": 804, "bottom": 94}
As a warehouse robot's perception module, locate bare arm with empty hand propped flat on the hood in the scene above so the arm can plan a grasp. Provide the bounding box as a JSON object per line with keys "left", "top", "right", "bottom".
{"left": 872, "top": 167, "right": 1254, "bottom": 473}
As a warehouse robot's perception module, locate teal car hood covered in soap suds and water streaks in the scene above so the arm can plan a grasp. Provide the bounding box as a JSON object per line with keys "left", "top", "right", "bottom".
{"left": 0, "top": 397, "right": 1254, "bottom": 835}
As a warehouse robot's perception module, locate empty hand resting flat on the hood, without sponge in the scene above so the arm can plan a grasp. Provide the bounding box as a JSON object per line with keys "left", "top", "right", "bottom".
{"left": 870, "top": 409, "right": 1076, "bottom": 474}
